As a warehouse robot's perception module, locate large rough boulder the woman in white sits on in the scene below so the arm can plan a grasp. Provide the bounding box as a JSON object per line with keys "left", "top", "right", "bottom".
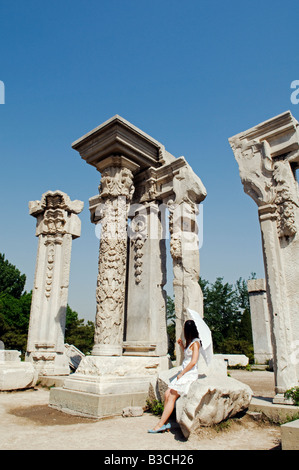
{"left": 176, "top": 376, "right": 252, "bottom": 438}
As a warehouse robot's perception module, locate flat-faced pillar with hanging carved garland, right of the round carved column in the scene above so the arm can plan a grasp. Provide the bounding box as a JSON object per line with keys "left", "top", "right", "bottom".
{"left": 124, "top": 201, "right": 168, "bottom": 357}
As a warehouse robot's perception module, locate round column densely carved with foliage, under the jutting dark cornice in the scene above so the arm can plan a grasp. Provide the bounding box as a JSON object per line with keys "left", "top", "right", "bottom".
{"left": 92, "top": 157, "right": 137, "bottom": 356}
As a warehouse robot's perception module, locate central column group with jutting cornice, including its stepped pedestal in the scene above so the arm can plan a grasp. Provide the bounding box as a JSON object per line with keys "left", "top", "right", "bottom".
{"left": 50, "top": 116, "right": 213, "bottom": 416}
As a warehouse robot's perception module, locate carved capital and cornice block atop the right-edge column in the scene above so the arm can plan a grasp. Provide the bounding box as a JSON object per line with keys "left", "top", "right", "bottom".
{"left": 229, "top": 112, "right": 299, "bottom": 238}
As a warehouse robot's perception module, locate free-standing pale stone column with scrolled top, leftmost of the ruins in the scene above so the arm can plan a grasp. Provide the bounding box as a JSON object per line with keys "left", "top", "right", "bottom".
{"left": 26, "top": 191, "right": 83, "bottom": 375}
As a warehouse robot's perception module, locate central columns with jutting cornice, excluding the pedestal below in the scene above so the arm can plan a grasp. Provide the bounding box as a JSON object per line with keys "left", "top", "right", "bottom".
{"left": 73, "top": 116, "right": 206, "bottom": 364}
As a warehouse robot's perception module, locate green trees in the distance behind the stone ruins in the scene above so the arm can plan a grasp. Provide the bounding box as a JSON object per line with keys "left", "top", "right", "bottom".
{"left": 0, "top": 253, "right": 255, "bottom": 362}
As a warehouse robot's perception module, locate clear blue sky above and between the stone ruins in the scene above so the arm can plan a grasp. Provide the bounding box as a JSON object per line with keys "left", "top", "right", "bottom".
{"left": 0, "top": 0, "right": 299, "bottom": 320}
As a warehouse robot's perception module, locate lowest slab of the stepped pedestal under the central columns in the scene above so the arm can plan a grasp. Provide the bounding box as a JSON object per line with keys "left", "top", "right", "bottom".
{"left": 49, "top": 388, "right": 148, "bottom": 418}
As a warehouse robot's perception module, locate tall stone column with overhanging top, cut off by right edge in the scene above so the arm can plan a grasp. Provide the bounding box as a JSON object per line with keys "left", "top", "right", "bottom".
{"left": 229, "top": 111, "right": 299, "bottom": 403}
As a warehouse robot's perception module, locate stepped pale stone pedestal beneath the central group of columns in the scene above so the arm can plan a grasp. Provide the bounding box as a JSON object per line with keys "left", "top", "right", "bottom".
{"left": 49, "top": 356, "right": 169, "bottom": 418}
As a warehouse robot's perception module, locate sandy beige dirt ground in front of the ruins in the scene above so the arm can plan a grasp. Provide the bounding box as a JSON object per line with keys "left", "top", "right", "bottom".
{"left": 0, "top": 370, "right": 280, "bottom": 451}
